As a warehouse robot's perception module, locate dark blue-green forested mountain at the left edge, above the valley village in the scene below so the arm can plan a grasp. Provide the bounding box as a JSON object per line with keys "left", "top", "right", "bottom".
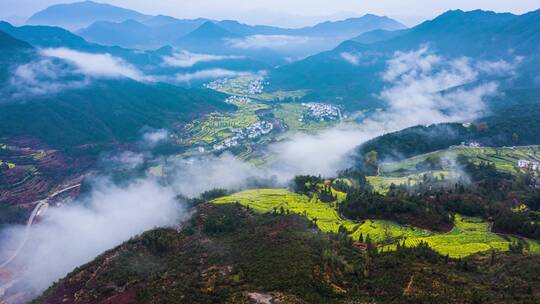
{"left": 0, "top": 28, "right": 234, "bottom": 149}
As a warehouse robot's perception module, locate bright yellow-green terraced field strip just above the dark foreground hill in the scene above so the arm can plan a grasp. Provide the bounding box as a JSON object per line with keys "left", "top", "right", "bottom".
{"left": 213, "top": 189, "right": 540, "bottom": 258}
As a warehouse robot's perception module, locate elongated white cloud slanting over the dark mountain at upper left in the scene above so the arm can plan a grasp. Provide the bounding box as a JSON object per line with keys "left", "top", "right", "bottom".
{"left": 41, "top": 48, "right": 151, "bottom": 81}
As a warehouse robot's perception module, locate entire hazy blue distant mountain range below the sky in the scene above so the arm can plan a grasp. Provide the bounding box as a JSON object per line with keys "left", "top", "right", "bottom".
{"left": 21, "top": 1, "right": 406, "bottom": 57}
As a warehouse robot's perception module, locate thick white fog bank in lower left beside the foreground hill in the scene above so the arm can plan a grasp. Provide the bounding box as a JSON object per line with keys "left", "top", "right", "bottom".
{"left": 0, "top": 179, "right": 187, "bottom": 294}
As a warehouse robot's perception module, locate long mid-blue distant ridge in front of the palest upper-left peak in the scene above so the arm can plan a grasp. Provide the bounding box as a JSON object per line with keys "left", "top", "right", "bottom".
{"left": 77, "top": 15, "right": 405, "bottom": 57}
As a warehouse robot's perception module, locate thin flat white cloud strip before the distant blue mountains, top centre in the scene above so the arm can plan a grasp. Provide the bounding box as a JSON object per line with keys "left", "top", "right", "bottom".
{"left": 228, "top": 35, "right": 312, "bottom": 50}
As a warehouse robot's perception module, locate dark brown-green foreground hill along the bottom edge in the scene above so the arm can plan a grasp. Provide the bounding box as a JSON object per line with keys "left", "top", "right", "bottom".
{"left": 35, "top": 203, "right": 540, "bottom": 304}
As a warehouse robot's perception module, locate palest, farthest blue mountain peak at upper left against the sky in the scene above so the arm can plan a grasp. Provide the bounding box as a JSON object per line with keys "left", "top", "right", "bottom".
{"left": 27, "top": 1, "right": 147, "bottom": 30}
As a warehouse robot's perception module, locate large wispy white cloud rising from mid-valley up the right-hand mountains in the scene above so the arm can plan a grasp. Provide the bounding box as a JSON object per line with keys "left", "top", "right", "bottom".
{"left": 269, "top": 47, "right": 513, "bottom": 176}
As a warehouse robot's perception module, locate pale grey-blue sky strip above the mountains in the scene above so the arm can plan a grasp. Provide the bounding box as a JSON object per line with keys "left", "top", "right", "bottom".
{"left": 0, "top": 0, "right": 540, "bottom": 26}
